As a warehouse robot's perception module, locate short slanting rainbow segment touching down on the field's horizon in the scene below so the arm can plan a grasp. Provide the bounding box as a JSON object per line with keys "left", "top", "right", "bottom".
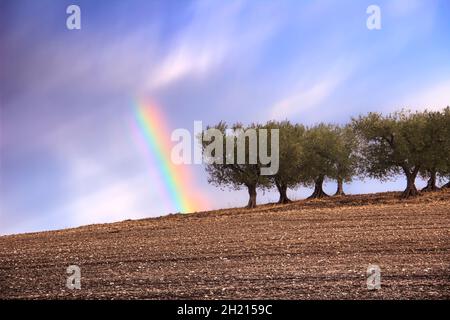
{"left": 134, "top": 102, "right": 205, "bottom": 213}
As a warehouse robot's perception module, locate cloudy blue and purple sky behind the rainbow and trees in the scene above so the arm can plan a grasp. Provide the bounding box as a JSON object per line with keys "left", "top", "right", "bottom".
{"left": 0, "top": 0, "right": 450, "bottom": 234}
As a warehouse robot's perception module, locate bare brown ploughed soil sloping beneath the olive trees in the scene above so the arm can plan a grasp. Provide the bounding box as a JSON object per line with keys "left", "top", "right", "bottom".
{"left": 0, "top": 190, "right": 450, "bottom": 299}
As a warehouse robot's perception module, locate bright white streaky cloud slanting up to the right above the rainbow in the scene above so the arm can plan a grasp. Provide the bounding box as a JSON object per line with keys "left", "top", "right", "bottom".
{"left": 147, "top": 1, "right": 278, "bottom": 90}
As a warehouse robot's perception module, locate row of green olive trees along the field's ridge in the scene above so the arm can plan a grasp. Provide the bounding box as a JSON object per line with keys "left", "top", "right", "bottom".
{"left": 202, "top": 107, "right": 450, "bottom": 208}
